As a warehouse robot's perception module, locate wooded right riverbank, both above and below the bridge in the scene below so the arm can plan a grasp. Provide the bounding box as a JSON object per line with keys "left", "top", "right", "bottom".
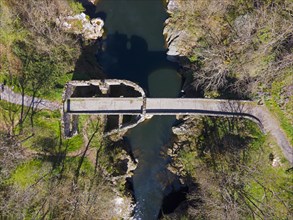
{"left": 164, "top": 0, "right": 293, "bottom": 219}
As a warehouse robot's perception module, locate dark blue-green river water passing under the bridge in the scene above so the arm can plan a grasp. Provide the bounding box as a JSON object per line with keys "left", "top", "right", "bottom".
{"left": 96, "top": 0, "right": 181, "bottom": 220}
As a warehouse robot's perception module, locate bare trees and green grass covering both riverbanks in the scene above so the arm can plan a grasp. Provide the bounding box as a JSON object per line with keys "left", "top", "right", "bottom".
{"left": 0, "top": 0, "right": 293, "bottom": 219}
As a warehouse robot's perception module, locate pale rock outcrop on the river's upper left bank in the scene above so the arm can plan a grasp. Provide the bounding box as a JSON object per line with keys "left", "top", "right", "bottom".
{"left": 56, "top": 13, "right": 104, "bottom": 40}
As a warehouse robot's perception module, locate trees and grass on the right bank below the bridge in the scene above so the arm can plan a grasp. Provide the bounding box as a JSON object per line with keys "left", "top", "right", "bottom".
{"left": 170, "top": 118, "right": 293, "bottom": 219}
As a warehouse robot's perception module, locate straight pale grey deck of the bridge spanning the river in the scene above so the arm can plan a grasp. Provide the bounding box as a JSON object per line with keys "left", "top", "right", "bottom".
{"left": 64, "top": 97, "right": 251, "bottom": 115}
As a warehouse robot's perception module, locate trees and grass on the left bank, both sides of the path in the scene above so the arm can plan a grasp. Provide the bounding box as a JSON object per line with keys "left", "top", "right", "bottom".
{"left": 0, "top": 0, "right": 130, "bottom": 219}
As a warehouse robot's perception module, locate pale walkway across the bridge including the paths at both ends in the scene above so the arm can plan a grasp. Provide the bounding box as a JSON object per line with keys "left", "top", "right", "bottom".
{"left": 0, "top": 86, "right": 293, "bottom": 164}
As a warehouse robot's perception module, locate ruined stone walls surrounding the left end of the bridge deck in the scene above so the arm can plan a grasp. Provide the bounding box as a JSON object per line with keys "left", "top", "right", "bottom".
{"left": 62, "top": 79, "right": 146, "bottom": 137}
